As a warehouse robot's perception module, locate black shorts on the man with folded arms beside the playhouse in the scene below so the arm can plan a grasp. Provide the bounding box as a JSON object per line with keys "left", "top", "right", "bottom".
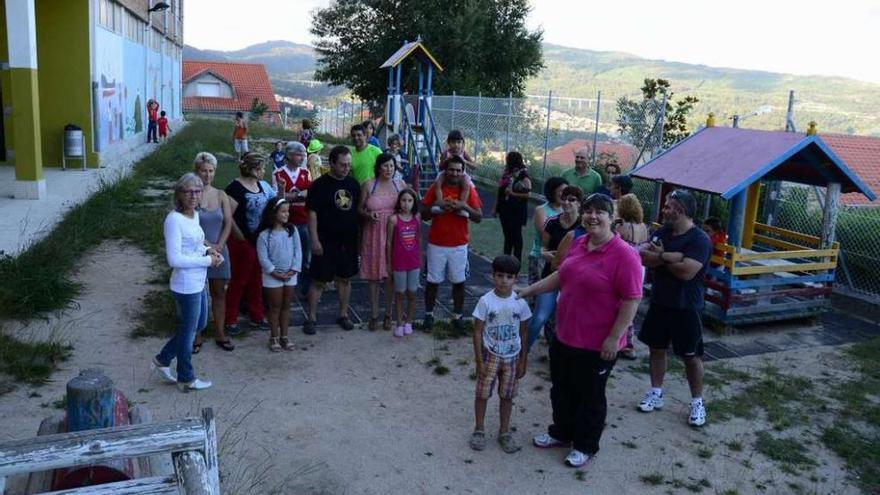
{"left": 639, "top": 304, "right": 703, "bottom": 357}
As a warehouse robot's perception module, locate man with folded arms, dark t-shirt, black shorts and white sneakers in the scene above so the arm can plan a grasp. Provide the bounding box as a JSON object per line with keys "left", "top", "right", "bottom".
{"left": 639, "top": 189, "right": 712, "bottom": 426}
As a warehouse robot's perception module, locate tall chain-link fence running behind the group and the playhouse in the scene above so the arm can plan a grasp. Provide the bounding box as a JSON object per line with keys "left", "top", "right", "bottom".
{"left": 317, "top": 93, "right": 880, "bottom": 301}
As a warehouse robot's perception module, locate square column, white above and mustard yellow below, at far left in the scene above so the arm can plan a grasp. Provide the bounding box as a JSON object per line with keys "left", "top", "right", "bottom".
{"left": 6, "top": 0, "right": 46, "bottom": 199}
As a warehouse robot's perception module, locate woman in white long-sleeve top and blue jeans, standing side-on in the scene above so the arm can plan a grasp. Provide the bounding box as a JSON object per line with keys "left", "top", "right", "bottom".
{"left": 153, "top": 173, "right": 223, "bottom": 392}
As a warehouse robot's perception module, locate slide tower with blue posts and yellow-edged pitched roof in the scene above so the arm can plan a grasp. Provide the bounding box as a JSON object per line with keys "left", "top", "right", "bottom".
{"left": 379, "top": 37, "right": 443, "bottom": 193}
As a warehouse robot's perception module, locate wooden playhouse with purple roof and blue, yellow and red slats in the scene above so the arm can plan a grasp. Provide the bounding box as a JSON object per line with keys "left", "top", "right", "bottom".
{"left": 632, "top": 121, "right": 876, "bottom": 327}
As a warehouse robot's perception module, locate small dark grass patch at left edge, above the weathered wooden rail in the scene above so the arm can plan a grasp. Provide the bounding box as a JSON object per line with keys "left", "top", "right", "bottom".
{"left": 0, "top": 334, "right": 73, "bottom": 385}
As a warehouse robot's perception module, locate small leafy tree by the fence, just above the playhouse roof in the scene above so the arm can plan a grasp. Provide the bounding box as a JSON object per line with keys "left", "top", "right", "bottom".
{"left": 617, "top": 78, "right": 700, "bottom": 152}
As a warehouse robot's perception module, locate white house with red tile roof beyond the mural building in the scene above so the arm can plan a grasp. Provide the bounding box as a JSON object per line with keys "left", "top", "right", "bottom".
{"left": 183, "top": 60, "right": 281, "bottom": 124}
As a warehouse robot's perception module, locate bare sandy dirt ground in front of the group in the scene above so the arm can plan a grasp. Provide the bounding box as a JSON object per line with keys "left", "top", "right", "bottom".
{"left": 0, "top": 243, "right": 858, "bottom": 495}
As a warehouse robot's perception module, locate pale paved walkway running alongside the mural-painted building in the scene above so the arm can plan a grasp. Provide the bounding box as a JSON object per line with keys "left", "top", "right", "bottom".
{"left": 0, "top": 133, "right": 181, "bottom": 256}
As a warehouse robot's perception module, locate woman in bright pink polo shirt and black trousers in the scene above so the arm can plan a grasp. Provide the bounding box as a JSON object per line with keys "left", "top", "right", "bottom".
{"left": 519, "top": 193, "right": 642, "bottom": 467}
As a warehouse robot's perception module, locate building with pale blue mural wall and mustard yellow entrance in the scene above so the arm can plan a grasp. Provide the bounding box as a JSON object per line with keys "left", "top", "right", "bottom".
{"left": 0, "top": 0, "right": 183, "bottom": 199}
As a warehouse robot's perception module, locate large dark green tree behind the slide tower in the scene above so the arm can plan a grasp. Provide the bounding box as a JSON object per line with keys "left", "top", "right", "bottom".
{"left": 311, "top": 0, "right": 543, "bottom": 101}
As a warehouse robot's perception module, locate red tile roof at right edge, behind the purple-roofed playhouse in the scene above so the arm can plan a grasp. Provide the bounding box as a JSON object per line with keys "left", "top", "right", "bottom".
{"left": 819, "top": 134, "right": 880, "bottom": 207}
